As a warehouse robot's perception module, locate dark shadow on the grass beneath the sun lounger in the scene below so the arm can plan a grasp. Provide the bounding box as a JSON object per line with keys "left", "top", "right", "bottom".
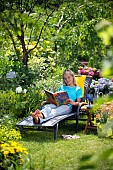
{"left": 18, "top": 120, "right": 94, "bottom": 143}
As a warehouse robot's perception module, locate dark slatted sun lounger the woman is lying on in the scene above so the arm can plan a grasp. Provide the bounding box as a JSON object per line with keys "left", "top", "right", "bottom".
{"left": 16, "top": 77, "right": 92, "bottom": 140}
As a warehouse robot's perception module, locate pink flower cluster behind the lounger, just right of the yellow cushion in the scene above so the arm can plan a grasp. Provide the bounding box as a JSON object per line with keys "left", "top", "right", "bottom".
{"left": 78, "top": 66, "right": 100, "bottom": 79}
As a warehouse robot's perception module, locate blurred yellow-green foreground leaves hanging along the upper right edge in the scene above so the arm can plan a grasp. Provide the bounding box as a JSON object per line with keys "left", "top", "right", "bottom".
{"left": 96, "top": 20, "right": 113, "bottom": 76}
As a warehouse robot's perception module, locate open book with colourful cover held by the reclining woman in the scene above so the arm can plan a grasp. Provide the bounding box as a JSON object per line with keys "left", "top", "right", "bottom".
{"left": 44, "top": 90, "right": 69, "bottom": 106}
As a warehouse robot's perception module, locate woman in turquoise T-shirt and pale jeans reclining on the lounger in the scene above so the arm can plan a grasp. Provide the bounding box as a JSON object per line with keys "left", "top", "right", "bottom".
{"left": 32, "top": 70, "right": 82, "bottom": 124}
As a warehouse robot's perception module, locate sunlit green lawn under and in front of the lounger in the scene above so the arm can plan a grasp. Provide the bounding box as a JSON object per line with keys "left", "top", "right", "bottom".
{"left": 18, "top": 121, "right": 113, "bottom": 170}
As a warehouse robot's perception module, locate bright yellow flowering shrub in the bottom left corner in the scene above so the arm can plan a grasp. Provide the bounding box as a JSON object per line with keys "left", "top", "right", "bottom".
{"left": 0, "top": 141, "right": 28, "bottom": 170}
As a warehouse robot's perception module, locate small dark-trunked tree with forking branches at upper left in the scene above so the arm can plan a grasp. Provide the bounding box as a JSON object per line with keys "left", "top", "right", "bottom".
{"left": 0, "top": 0, "right": 59, "bottom": 66}
